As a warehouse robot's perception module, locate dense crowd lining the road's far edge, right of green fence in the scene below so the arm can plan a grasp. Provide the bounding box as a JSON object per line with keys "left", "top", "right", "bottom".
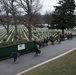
{"left": 36, "top": 32, "right": 73, "bottom": 48}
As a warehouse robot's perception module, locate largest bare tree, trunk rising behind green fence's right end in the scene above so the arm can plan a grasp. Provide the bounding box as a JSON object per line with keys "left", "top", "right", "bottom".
{"left": 17, "top": 0, "right": 42, "bottom": 41}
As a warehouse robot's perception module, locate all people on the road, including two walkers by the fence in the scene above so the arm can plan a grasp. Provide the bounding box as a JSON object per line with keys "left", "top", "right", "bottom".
{"left": 12, "top": 32, "right": 73, "bottom": 63}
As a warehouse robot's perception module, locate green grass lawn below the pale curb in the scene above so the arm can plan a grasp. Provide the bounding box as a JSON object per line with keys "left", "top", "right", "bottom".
{"left": 21, "top": 50, "right": 76, "bottom": 75}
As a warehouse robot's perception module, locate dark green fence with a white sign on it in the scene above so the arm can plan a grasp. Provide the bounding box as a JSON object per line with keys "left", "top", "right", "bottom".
{"left": 0, "top": 41, "right": 36, "bottom": 60}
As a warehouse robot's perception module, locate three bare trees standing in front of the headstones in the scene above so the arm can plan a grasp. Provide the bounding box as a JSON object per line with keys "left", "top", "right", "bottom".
{"left": 0, "top": 0, "right": 42, "bottom": 41}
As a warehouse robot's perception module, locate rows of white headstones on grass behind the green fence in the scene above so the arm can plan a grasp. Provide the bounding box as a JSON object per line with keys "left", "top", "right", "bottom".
{"left": 0, "top": 25, "right": 55, "bottom": 42}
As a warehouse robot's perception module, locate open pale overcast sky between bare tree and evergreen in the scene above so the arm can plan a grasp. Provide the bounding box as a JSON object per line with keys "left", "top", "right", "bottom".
{"left": 41, "top": 0, "right": 76, "bottom": 14}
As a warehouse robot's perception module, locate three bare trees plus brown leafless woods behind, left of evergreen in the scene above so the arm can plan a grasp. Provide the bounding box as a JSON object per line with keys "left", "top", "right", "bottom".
{"left": 0, "top": 0, "right": 51, "bottom": 41}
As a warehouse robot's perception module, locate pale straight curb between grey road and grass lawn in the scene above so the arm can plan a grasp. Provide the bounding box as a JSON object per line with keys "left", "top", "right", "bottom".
{"left": 15, "top": 48, "right": 76, "bottom": 75}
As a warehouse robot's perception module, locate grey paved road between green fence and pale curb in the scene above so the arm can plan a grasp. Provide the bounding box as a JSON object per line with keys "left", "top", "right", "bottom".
{"left": 0, "top": 38, "right": 76, "bottom": 75}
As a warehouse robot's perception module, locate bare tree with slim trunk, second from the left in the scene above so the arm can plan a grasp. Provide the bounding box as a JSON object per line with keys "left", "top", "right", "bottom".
{"left": 0, "top": 0, "right": 19, "bottom": 39}
